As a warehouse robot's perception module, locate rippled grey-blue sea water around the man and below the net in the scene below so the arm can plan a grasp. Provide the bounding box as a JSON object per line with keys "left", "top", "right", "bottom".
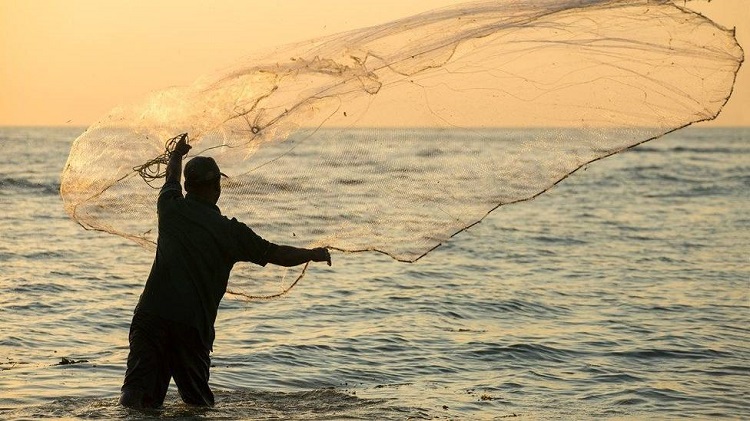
{"left": 0, "top": 128, "right": 750, "bottom": 420}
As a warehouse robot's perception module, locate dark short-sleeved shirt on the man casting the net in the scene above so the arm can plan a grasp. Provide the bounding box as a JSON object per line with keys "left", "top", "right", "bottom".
{"left": 137, "top": 183, "right": 273, "bottom": 348}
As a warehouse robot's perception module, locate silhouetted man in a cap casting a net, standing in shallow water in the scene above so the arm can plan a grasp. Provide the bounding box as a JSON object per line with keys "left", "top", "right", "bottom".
{"left": 120, "top": 135, "right": 331, "bottom": 409}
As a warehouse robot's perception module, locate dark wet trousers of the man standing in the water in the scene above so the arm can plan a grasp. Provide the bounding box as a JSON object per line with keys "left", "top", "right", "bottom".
{"left": 120, "top": 312, "right": 214, "bottom": 409}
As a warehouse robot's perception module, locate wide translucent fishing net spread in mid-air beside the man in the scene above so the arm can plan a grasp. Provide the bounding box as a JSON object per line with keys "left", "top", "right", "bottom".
{"left": 61, "top": 0, "right": 743, "bottom": 296}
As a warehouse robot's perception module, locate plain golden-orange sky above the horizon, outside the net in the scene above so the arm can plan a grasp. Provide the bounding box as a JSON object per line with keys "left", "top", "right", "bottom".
{"left": 0, "top": 0, "right": 750, "bottom": 126}
